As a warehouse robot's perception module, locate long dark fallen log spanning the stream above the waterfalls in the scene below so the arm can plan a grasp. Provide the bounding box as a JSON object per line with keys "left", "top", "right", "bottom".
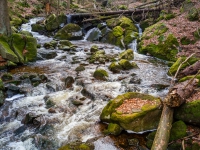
{"left": 70, "top": 8, "right": 161, "bottom": 21}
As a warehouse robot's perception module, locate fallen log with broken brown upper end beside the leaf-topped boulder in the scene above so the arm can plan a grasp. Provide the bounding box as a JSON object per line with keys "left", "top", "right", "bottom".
{"left": 151, "top": 79, "right": 198, "bottom": 150}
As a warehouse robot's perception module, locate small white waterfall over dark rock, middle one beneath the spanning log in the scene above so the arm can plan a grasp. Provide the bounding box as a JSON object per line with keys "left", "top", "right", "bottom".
{"left": 84, "top": 28, "right": 101, "bottom": 41}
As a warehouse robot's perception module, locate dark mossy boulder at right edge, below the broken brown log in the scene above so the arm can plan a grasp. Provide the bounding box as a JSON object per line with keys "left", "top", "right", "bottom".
{"left": 174, "top": 100, "right": 200, "bottom": 126}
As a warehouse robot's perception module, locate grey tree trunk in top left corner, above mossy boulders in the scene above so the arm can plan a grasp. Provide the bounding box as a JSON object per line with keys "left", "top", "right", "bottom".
{"left": 0, "top": 0, "right": 11, "bottom": 36}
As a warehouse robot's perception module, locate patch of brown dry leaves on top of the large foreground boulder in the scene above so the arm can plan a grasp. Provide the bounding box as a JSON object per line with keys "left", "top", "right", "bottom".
{"left": 115, "top": 98, "right": 156, "bottom": 114}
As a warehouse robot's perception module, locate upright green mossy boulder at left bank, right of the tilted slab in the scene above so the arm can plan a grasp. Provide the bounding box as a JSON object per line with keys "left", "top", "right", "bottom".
{"left": 11, "top": 33, "right": 37, "bottom": 63}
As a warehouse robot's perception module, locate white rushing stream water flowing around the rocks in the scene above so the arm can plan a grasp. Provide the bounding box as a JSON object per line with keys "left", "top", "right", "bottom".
{"left": 0, "top": 18, "right": 172, "bottom": 150}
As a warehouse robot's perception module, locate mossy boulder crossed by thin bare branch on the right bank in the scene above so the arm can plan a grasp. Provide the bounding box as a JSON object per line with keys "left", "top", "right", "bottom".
{"left": 168, "top": 57, "right": 199, "bottom": 75}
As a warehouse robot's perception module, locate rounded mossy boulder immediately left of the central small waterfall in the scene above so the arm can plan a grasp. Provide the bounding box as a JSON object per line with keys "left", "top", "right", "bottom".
{"left": 55, "top": 23, "right": 83, "bottom": 40}
